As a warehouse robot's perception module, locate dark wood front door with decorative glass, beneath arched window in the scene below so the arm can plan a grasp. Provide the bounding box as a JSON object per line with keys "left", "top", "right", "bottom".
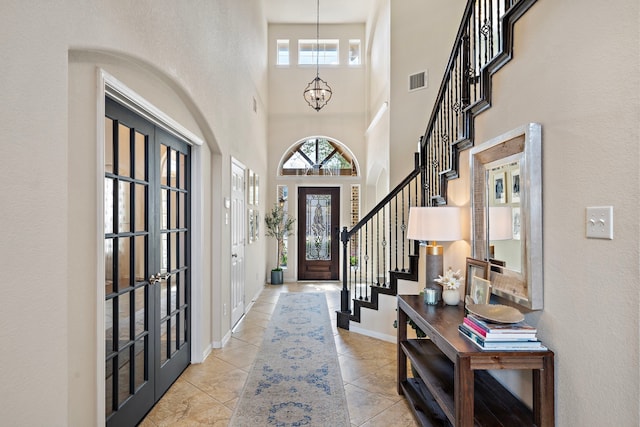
{"left": 298, "top": 187, "right": 340, "bottom": 280}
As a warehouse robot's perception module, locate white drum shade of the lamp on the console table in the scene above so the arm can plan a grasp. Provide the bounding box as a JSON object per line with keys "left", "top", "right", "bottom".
{"left": 407, "top": 206, "right": 462, "bottom": 242}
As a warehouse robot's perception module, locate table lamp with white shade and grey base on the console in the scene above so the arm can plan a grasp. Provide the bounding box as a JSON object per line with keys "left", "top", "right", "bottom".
{"left": 407, "top": 206, "right": 462, "bottom": 300}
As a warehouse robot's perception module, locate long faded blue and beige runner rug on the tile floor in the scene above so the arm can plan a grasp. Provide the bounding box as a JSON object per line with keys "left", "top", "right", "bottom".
{"left": 229, "top": 292, "right": 350, "bottom": 427}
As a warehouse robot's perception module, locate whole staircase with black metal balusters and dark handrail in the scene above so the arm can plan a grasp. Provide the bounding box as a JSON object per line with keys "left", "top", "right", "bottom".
{"left": 337, "top": 0, "right": 536, "bottom": 329}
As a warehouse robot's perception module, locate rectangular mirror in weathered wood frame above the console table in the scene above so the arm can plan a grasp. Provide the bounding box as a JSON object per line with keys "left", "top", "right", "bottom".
{"left": 470, "top": 123, "right": 543, "bottom": 310}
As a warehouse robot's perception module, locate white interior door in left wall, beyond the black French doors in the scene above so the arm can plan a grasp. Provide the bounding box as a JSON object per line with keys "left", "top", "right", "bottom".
{"left": 231, "top": 160, "right": 246, "bottom": 325}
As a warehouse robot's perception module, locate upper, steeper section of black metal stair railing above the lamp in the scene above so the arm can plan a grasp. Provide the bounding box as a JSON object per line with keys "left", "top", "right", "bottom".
{"left": 420, "top": 0, "right": 536, "bottom": 205}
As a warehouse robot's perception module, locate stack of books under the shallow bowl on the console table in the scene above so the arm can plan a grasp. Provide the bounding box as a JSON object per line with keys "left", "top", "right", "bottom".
{"left": 458, "top": 314, "right": 547, "bottom": 351}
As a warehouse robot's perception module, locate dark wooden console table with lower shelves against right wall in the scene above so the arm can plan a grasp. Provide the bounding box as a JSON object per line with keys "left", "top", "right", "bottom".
{"left": 398, "top": 295, "right": 555, "bottom": 427}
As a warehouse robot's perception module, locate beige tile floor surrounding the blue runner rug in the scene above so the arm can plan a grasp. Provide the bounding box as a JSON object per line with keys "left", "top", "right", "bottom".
{"left": 140, "top": 283, "right": 417, "bottom": 427}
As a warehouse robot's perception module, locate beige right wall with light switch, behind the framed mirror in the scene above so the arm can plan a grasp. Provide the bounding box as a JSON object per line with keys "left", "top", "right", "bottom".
{"left": 449, "top": 0, "right": 640, "bottom": 426}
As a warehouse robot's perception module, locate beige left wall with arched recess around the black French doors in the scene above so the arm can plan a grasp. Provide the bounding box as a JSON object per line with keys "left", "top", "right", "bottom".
{"left": 0, "top": 0, "right": 267, "bottom": 426}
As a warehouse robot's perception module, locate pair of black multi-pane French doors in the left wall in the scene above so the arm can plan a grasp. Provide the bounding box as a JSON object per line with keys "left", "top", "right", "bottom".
{"left": 104, "top": 99, "right": 191, "bottom": 426}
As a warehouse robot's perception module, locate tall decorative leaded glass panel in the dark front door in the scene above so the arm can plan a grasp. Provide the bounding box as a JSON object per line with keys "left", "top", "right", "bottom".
{"left": 305, "top": 194, "right": 331, "bottom": 261}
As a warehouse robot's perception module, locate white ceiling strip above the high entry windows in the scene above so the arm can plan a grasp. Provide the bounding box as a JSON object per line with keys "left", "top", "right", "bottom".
{"left": 264, "top": 0, "right": 376, "bottom": 24}
